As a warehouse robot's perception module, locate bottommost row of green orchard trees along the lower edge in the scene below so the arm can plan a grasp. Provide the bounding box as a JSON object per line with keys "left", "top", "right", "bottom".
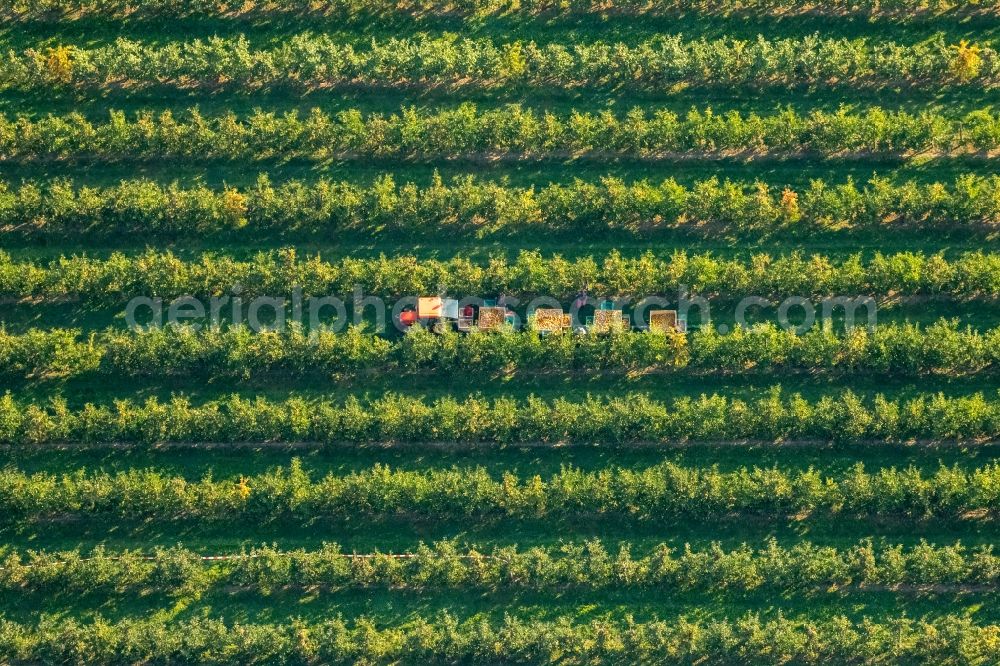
{"left": 0, "top": 614, "right": 1000, "bottom": 665}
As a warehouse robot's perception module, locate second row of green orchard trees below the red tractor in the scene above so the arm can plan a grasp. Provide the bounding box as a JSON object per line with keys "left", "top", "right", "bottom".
{"left": 0, "top": 387, "right": 1000, "bottom": 446}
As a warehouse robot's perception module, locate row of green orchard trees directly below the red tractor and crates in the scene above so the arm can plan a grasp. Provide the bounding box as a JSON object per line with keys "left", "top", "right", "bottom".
{"left": 0, "top": 320, "right": 1000, "bottom": 378}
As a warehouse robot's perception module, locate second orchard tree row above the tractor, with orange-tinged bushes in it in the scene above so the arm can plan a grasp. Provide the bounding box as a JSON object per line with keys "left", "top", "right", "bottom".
{"left": 0, "top": 174, "right": 1000, "bottom": 238}
